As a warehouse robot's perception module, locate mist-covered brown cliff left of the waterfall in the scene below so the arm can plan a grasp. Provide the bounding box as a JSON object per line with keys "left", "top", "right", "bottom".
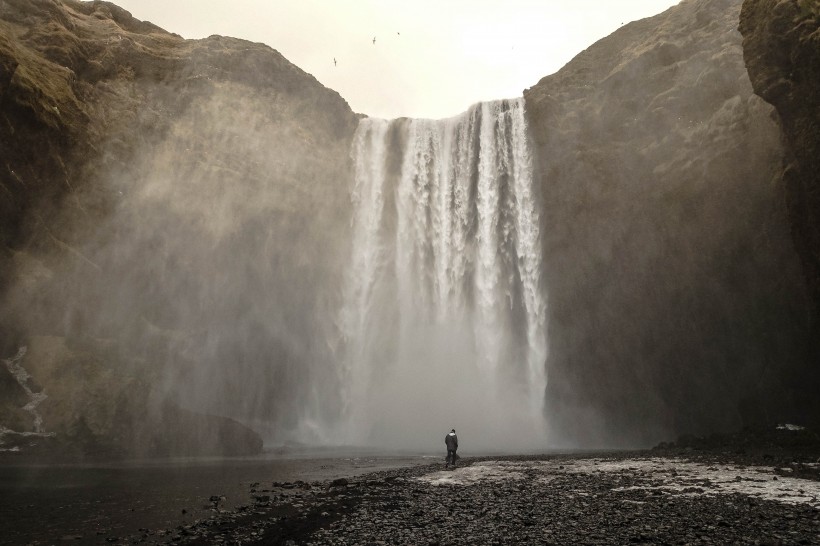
{"left": 0, "top": 0, "right": 357, "bottom": 453}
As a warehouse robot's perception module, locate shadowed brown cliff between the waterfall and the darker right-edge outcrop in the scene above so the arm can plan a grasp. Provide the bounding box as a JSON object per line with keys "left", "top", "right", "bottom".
{"left": 525, "top": 0, "right": 815, "bottom": 445}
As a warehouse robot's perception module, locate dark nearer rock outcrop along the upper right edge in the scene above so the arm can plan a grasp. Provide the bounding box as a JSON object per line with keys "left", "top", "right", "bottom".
{"left": 739, "top": 0, "right": 820, "bottom": 346}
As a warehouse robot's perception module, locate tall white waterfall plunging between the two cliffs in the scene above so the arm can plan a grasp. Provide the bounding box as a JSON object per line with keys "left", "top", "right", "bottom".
{"left": 339, "top": 99, "right": 547, "bottom": 450}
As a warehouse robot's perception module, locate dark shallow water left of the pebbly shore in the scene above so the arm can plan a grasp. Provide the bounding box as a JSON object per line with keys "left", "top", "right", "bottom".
{"left": 0, "top": 453, "right": 436, "bottom": 545}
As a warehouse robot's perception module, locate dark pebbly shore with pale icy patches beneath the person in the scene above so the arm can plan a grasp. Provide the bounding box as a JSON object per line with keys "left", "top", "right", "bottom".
{"left": 85, "top": 430, "right": 820, "bottom": 544}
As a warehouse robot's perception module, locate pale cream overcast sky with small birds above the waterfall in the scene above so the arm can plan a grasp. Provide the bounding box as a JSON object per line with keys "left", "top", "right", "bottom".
{"left": 113, "top": 0, "right": 678, "bottom": 118}
